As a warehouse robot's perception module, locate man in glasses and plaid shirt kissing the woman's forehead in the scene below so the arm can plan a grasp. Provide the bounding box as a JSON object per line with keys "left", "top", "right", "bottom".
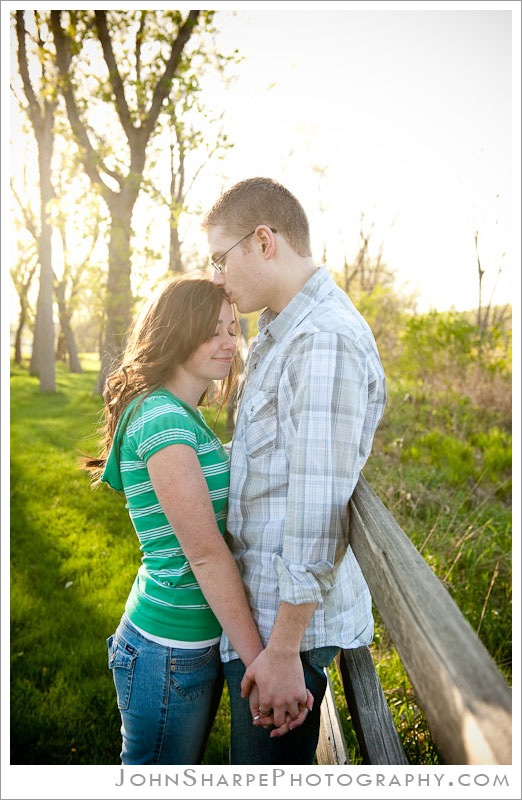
{"left": 203, "top": 178, "right": 386, "bottom": 764}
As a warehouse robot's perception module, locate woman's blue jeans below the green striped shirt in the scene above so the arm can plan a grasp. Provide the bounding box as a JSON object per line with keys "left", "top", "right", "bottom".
{"left": 107, "top": 617, "right": 223, "bottom": 764}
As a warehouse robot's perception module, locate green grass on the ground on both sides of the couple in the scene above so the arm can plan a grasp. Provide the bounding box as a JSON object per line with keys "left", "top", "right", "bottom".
{"left": 10, "top": 357, "right": 511, "bottom": 765}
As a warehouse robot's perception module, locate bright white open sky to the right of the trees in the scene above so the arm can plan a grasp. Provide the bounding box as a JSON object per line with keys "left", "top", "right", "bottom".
{"left": 193, "top": 2, "right": 520, "bottom": 310}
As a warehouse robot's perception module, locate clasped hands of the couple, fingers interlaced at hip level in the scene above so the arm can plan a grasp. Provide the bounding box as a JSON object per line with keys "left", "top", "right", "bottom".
{"left": 241, "top": 649, "right": 314, "bottom": 738}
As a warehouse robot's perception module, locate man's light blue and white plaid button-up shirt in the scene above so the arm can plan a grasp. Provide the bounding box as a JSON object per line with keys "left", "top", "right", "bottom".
{"left": 221, "top": 267, "right": 386, "bottom": 661}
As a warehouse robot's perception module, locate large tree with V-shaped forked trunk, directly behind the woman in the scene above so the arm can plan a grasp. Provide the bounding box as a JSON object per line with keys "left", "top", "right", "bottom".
{"left": 51, "top": 10, "right": 200, "bottom": 391}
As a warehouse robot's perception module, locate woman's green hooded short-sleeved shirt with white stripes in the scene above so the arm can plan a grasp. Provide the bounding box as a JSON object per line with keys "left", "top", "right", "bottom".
{"left": 102, "top": 389, "right": 230, "bottom": 642}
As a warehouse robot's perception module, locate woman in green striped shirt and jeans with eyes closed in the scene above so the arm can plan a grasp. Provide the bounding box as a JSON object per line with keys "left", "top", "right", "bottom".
{"left": 83, "top": 276, "right": 263, "bottom": 764}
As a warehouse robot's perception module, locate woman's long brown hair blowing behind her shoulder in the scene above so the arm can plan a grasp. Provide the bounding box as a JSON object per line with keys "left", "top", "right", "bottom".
{"left": 80, "top": 276, "right": 237, "bottom": 483}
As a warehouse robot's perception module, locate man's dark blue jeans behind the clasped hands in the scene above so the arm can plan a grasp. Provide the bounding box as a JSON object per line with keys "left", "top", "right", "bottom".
{"left": 223, "top": 647, "right": 339, "bottom": 764}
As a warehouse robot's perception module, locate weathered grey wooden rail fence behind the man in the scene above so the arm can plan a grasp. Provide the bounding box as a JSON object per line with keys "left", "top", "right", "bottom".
{"left": 317, "top": 476, "right": 512, "bottom": 764}
